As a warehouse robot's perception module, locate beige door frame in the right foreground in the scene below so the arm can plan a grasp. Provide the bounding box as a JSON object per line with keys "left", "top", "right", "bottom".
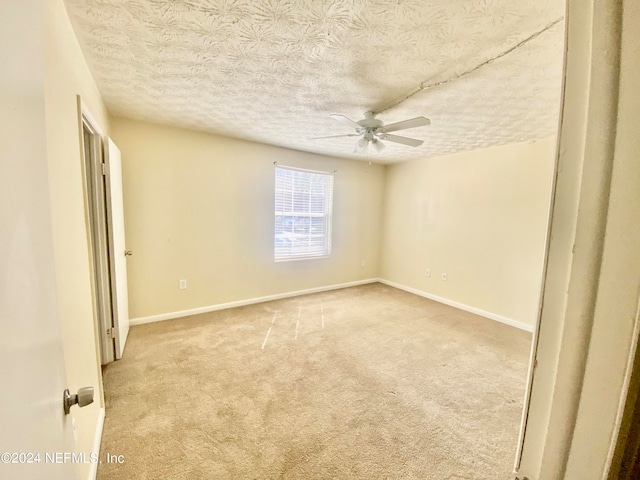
{"left": 517, "top": 0, "right": 640, "bottom": 480}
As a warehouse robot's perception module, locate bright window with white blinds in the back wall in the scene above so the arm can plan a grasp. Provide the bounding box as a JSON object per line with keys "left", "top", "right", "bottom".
{"left": 274, "top": 167, "right": 333, "bottom": 261}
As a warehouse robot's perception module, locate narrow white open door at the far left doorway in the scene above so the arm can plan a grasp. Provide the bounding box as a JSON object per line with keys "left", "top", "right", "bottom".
{"left": 105, "top": 138, "right": 131, "bottom": 359}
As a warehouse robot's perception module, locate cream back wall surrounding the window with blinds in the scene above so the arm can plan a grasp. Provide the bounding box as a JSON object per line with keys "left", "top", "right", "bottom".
{"left": 112, "top": 118, "right": 384, "bottom": 318}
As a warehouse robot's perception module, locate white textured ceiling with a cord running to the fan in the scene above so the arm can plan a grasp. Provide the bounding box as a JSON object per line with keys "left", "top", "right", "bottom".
{"left": 66, "top": 0, "right": 564, "bottom": 163}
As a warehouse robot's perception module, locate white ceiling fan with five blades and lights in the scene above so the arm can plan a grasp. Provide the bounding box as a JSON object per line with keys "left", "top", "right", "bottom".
{"left": 313, "top": 112, "right": 431, "bottom": 152}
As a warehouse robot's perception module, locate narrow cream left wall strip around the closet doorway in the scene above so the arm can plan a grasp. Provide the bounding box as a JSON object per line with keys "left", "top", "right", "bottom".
{"left": 45, "top": 0, "right": 109, "bottom": 478}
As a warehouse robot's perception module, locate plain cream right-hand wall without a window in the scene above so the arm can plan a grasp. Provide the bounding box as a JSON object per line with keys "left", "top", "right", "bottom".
{"left": 380, "top": 139, "right": 555, "bottom": 326}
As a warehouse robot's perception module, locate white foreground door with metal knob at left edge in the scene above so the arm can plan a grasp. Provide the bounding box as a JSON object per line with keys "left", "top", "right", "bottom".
{"left": 0, "top": 1, "right": 78, "bottom": 472}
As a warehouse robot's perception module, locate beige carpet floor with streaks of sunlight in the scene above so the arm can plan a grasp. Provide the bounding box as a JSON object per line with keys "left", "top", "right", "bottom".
{"left": 98, "top": 284, "right": 531, "bottom": 480}
